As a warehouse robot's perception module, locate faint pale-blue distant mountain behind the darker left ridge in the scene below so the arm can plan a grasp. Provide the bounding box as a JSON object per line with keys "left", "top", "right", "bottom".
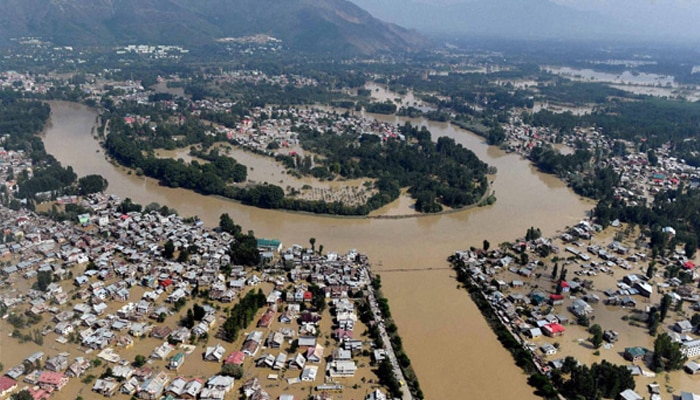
{"left": 352, "top": 0, "right": 642, "bottom": 39}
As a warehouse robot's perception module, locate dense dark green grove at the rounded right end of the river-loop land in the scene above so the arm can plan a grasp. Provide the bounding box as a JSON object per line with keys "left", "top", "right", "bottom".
{"left": 294, "top": 122, "right": 488, "bottom": 212}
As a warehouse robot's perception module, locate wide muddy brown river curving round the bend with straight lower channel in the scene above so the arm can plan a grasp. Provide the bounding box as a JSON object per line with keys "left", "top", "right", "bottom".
{"left": 44, "top": 102, "right": 593, "bottom": 399}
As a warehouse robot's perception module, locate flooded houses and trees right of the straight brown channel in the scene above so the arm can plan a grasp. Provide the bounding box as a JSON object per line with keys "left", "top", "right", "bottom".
{"left": 451, "top": 217, "right": 700, "bottom": 400}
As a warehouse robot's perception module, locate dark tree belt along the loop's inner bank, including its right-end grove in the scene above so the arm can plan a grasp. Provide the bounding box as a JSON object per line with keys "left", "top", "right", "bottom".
{"left": 105, "top": 110, "right": 488, "bottom": 215}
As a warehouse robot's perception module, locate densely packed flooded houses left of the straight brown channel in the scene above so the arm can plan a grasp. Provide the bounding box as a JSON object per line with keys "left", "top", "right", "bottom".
{"left": 0, "top": 189, "right": 410, "bottom": 400}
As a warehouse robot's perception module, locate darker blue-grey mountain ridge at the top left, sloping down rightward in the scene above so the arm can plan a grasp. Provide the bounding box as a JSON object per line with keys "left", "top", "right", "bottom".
{"left": 0, "top": 0, "right": 425, "bottom": 53}
